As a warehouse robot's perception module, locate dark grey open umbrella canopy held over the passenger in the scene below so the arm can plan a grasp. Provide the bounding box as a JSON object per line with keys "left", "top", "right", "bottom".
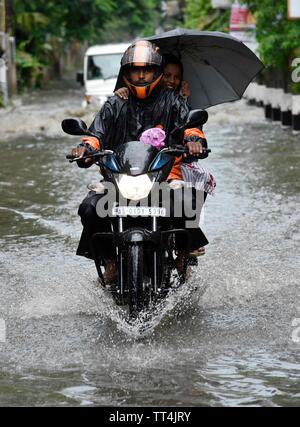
{"left": 147, "top": 28, "right": 263, "bottom": 108}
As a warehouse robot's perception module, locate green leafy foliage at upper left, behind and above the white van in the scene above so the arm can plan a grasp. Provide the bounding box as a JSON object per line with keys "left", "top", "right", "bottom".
{"left": 11, "top": 0, "right": 160, "bottom": 86}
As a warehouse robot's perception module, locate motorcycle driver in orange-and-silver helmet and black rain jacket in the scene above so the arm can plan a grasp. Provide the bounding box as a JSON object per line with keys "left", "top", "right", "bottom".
{"left": 71, "top": 41, "right": 208, "bottom": 281}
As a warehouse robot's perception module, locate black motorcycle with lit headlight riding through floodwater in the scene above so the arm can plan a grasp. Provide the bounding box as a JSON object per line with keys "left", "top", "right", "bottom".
{"left": 62, "top": 110, "right": 210, "bottom": 319}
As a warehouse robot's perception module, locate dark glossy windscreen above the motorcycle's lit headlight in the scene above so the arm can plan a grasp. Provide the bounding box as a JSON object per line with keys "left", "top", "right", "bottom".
{"left": 115, "top": 141, "right": 158, "bottom": 176}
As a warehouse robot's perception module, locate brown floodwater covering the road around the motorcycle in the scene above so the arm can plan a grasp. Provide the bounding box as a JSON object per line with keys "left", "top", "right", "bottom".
{"left": 0, "top": 91, "right": 300, "bottom": 407}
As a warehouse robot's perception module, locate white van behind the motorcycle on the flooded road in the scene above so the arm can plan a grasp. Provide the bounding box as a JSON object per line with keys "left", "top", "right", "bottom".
{"left": 77, "top": 43, "right": 130, "bottom": 107}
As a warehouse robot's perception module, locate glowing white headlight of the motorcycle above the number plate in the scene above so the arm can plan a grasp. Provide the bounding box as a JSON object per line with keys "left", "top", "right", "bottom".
{"left": 117, "top": 174, "right": 154, "bottom": 200}
